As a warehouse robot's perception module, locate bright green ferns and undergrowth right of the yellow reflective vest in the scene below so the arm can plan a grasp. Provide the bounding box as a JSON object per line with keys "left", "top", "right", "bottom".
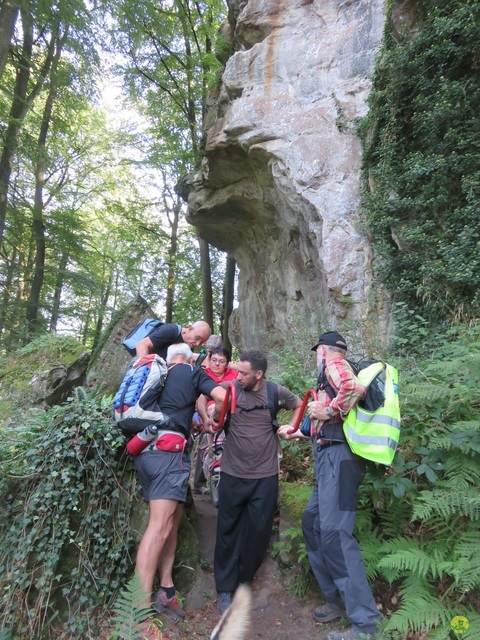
{"left": 357, "top": 327, "right": 480, "bottom": 638}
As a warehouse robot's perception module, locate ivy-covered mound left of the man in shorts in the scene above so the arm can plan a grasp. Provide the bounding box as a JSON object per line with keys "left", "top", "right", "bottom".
{"left": 0, "top": 394, "right": 138, "bottom": 639}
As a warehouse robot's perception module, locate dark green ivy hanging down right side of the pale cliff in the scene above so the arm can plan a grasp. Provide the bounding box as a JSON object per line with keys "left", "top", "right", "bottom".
{"left": 363, "top": 0, "right": 480, "bottom": 325}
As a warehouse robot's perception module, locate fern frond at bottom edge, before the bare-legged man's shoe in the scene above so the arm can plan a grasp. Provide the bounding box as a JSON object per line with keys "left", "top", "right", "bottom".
{"left": 112, "top": 572, "right": 152, "bottom": 640}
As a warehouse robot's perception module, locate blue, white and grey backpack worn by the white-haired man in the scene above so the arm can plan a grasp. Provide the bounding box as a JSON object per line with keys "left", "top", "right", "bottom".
{"left": 113, "top": 354, "right": 168, "bottom": 435}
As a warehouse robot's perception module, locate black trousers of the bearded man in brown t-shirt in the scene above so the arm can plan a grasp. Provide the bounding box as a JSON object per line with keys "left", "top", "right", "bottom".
{"left": 214, "top": 471, "right": 278, "bottom": 593}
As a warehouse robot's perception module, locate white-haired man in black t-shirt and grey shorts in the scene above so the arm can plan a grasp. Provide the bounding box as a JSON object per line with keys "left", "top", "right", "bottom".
{"left": 134, "top": 344, "right": 226, "bottom": 619}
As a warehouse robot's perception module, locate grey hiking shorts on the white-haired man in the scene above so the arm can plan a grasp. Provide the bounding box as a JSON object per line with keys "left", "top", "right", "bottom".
{"left": 134, "top": 451, "right": 190, "bottom": 502}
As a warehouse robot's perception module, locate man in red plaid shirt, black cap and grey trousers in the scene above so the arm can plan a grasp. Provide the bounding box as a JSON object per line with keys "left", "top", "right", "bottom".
{"left": 278, "top": 331, "right": 381, "bottom": 640}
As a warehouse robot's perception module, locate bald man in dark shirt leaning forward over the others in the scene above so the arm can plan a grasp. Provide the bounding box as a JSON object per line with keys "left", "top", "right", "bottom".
{"left": 135, "top": 320, "right": 211, "bottom": 359}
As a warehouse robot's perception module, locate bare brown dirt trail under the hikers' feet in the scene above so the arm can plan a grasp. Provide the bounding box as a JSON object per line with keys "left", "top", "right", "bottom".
{"left": 163, "top": 495, "right": 341, "bottom": 640}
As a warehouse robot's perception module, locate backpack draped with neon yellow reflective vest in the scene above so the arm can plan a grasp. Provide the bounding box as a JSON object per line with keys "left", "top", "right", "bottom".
{"left": 343, "top": 362, "right": 401, "bottom": 465}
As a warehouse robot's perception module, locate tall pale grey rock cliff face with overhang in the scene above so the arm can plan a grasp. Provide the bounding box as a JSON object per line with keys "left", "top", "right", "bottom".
{"left": 188, "top": 0, "right": 386, "bottom": 349}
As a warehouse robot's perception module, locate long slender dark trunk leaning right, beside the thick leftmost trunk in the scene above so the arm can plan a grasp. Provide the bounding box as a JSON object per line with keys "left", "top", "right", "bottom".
{"left": 26, "top": 28, "right": 68, "bottom": 338}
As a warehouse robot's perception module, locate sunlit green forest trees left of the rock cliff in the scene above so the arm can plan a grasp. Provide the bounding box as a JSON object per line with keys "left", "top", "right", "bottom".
{"left": 0, "top": 0, "right": 231, "bottom": 350}
